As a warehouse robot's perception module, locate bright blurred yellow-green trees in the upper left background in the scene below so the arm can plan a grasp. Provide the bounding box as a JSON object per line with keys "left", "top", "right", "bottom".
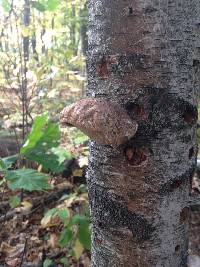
{"left": 0, "top": 0, "right": 87, "bottom": 136}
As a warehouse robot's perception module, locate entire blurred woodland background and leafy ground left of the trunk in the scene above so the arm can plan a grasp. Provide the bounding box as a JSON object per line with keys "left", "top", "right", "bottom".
{"left": 0, "top": 0, "right": 90, "bottom": 267}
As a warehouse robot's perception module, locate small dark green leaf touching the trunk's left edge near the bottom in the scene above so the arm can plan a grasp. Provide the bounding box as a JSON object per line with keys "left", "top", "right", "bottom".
{"left": 77, "top": 225, "right": 91, "bottom": 250}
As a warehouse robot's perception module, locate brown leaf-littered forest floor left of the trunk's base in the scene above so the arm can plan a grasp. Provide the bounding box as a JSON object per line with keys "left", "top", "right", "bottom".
{"left": 0, "top": 156, "right": 90, "bottom": 267}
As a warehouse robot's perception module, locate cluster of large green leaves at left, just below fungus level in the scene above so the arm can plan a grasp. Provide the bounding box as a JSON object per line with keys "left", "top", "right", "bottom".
{"left": 0, "top": 113, "right": 71, "bottom": 193}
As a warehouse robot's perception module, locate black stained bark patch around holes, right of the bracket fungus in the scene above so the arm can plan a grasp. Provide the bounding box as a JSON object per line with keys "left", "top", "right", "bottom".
{"left": 125, "top": 87, "right": 198, "bottom": 143}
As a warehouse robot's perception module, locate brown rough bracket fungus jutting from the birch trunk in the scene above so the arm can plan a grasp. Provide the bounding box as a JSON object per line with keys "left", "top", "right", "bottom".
{"left": 60, "top": 98, "right": 138, "bottom": 148}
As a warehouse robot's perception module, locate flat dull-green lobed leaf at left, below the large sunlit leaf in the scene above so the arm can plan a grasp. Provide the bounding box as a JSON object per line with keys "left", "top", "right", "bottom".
{"left": 5, "top": 169, "right": 52, "bottom": 191}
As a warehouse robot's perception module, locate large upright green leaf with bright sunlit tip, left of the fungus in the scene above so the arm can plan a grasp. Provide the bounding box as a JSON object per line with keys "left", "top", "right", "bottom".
{"left": 20, "top": 113, "right": 71, "bottom": 173}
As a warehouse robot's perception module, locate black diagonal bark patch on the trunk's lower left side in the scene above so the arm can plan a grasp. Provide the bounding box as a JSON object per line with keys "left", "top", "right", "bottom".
{"left": 90, "top": 185, "right": 154, "bottom": 242}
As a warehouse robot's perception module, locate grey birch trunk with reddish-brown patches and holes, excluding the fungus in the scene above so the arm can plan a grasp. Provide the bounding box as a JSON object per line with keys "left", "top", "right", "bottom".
{"left": 87, "top": 0, "right": 200, "bottom": 267}
